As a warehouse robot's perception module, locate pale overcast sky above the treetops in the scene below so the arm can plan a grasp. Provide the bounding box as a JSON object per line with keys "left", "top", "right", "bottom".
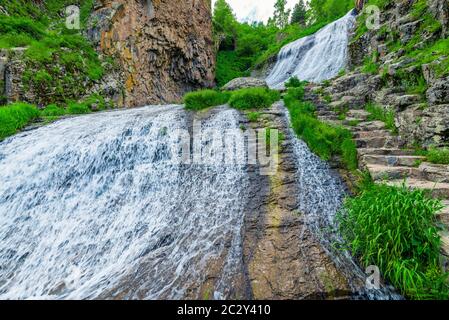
{"left": 212, "top": 0, "right": 297, "bottom": 22}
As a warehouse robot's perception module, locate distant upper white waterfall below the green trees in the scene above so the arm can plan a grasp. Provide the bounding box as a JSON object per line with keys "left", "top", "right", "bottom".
{"left": 266, "top": 11, "right": 355, "bottom": 89}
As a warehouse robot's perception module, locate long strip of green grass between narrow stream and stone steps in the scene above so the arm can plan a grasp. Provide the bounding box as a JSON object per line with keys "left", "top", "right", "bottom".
{"left": 284, "top": 88, "right": 358, "bottom": 170}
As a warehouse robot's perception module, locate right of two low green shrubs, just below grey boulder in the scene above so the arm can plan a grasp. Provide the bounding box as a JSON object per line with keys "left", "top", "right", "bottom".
{"left": 229, "top": 88, "right": 281, "bottom": 110}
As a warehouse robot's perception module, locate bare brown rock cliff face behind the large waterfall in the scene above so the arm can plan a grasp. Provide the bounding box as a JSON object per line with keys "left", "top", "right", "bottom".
{"left": 86, "top": 0, "right": 215, "bottom": 106}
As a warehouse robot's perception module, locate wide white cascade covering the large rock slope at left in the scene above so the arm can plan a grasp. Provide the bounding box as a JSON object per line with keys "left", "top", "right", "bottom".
{"left": 0, "top": 106, "right": 248, "bottom": 299}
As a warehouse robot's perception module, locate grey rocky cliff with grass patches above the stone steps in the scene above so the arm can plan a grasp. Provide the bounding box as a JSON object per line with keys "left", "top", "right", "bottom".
{"left": 332, "top": 0, "right": 449, "bottom": 146}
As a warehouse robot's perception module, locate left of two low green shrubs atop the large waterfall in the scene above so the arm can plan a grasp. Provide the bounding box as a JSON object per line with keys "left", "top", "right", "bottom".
{"left": 184, "top": 90, "right": 231, "bottom": 110}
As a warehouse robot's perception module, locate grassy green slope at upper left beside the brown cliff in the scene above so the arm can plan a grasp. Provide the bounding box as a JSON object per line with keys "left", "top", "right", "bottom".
{"left": 0, "top": 0, "right": 104, "bottom": 106}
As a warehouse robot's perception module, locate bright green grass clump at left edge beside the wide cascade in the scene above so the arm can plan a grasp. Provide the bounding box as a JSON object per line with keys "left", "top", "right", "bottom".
{"left": 0, "top": 103, "right": 39, "bottom": 140}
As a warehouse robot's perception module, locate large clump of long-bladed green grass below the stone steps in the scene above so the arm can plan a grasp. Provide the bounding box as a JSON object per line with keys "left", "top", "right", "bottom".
{"left": 338, "top": 184, "right": 449, "bottom": 299}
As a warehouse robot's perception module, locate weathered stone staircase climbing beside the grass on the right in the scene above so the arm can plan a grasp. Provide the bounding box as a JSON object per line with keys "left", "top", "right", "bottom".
{"left": 317, "top": 106, "right": 449, "bottom": 259}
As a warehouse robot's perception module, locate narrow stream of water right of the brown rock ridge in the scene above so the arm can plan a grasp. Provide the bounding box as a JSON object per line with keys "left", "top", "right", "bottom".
{"left": 287, "top": 109, "right": 402, "bottom": 300}
